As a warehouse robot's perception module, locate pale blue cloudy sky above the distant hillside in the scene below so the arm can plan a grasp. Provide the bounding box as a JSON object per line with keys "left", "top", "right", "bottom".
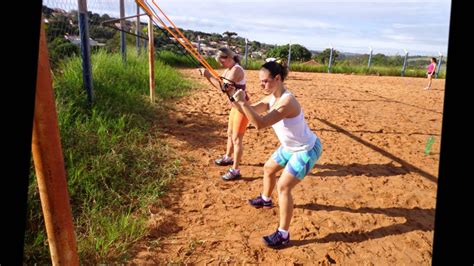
{"left": 45, "top": 0, "right": 451, "bottom": 56}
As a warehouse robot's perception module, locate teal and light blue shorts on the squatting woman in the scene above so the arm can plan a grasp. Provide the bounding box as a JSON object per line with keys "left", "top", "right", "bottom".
{"left": 272, "top": 138, "right": 323, "bottom": 180}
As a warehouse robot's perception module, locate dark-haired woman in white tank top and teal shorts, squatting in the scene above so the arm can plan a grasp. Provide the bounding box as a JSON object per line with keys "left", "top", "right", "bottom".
{"left": 233, "top": 60, "right": 322, "bottom": 247}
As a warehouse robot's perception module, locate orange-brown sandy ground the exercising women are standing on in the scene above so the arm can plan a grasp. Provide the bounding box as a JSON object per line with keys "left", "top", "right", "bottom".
{"left": 130, "top": 70, "right": 445, "bottom": 265}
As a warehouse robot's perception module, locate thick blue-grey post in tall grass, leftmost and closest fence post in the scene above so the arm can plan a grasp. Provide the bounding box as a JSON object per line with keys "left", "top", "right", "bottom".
{"left": 78, "top": 0, "right": 94, "bottom": 105}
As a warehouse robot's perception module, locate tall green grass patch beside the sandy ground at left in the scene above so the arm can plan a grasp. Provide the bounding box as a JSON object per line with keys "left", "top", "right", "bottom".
{"left": 24, "top": 52, "right": 192, "bottom": 264}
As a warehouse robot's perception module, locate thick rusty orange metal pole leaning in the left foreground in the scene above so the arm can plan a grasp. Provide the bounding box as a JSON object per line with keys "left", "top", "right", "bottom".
{"left": 32, "top": 22, "right": 79, "bottom": 265}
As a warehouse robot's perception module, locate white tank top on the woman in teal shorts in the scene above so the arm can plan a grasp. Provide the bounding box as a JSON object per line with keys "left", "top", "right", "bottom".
{"left": 269, "top": 91, "right": 318, "bottom": 152}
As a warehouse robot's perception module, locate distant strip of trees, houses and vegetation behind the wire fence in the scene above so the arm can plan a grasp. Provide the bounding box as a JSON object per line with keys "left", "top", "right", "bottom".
{"left": 43, "top": 6, "right": 447, "bottom": 77}
